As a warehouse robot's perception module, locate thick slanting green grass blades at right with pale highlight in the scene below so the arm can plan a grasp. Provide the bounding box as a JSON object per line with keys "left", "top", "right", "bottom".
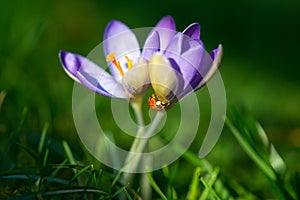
{"left": 225, "top": 113, "right": 297, "bottom": 200}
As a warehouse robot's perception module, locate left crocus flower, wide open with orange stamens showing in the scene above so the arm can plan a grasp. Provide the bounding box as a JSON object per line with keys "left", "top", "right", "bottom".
{"left": 59, "top": 16, "right": 175, "bottom": 100}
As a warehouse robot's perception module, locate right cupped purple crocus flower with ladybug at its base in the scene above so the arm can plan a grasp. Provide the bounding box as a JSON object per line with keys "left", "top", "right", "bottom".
{"left": 148, "top": 23, "right": 223, "bottom": 110}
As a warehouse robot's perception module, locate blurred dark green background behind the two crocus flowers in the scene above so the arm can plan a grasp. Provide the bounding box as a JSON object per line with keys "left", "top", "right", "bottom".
{"left": 0, "top": 0, "right": 300, "bottom": 196}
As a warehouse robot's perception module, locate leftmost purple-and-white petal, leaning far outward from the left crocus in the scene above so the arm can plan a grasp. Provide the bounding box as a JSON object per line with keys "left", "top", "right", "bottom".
{"left": 59, "top": 51, "right": 127, "bottom": 98}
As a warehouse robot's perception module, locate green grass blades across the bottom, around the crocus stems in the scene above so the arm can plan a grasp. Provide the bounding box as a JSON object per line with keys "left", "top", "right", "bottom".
{"left": 0, "top": 104, "right": 299, "bottom": 200}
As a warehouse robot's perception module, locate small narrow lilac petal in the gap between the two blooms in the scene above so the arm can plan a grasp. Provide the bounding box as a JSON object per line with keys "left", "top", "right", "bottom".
{"left": 142, "top": 31, "right": 160, "bottom": 60}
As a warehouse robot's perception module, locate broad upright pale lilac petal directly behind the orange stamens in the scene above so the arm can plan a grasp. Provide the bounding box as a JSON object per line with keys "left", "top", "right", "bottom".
{"left": 104, "top": 20, "right": 141, "bottom": 80}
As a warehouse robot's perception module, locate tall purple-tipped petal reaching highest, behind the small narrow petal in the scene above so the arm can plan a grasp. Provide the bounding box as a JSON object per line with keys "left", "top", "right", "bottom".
{"left": 154, "top": 16, "right": 176, "bottom": 50}
